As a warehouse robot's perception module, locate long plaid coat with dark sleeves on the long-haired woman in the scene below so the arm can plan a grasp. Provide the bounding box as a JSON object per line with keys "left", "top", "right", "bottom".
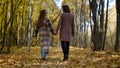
{"left": 35, "top": 19, "right": 54, "bottom": 52}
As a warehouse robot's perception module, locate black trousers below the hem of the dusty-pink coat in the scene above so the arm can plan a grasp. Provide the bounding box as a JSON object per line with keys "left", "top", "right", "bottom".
{"left": 61, "top": 41, "right": 70, "bottom": 58}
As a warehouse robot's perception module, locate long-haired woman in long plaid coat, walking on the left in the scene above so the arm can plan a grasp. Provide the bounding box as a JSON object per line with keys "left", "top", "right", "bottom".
{"left": 35, "top": 10, "right": 55, "bottom": 60}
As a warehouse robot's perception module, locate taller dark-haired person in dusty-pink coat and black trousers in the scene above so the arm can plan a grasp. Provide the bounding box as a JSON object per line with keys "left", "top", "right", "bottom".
{"left": 56, "top": 5, "right": 74, "bottom": 61}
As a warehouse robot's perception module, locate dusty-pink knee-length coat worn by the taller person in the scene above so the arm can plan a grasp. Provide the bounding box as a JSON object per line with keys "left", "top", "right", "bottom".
{"left": 56, "top": 13, "right": 74, "bottom": 41}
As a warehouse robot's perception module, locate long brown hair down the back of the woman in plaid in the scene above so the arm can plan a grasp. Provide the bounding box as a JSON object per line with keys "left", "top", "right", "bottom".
{"left": 37, "top": 10, "right": 46, "bottom": 27}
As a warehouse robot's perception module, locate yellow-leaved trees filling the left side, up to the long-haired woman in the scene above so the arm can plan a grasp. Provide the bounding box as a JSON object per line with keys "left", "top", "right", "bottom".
{"left": 0, "top": 0, "right": 59, "bottom": 53}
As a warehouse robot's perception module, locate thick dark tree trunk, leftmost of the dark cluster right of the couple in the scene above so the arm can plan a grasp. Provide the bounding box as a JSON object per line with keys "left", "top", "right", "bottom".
{"left": 89, "top": 0, "right": 99, "bottom": 51}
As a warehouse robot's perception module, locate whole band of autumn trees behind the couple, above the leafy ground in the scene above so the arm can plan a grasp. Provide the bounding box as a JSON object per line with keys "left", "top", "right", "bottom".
{"left": 0, "top": 0, "right": 120, "bottom": 53}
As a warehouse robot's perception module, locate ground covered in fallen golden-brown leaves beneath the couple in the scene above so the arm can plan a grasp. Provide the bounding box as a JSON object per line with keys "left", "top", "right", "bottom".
{"left": 0, "top": 46, "right": 120, "bottom": 68}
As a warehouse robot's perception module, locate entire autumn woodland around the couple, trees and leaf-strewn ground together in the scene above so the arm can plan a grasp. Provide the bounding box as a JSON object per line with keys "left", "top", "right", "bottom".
{"left": 0, "top": 0, "right": 120, "bottom": 68}
